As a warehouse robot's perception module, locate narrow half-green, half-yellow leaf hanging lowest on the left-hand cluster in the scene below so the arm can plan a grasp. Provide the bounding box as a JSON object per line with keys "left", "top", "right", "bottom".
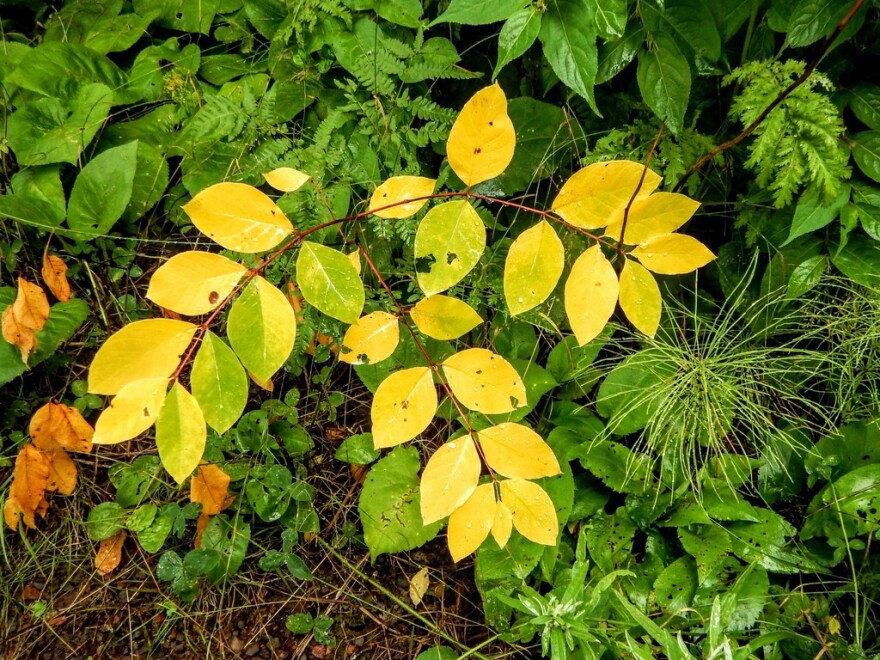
{"left": 156, "top": 383, "right": 208, "bottom": 484}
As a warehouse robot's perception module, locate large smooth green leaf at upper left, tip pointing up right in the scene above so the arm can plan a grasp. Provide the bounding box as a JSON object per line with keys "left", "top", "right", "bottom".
{"left": 67, "top": 142, "right": 138, "bottom": 238}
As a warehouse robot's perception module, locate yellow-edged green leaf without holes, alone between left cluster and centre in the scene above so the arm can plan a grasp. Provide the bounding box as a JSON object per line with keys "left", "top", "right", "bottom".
{"left": 296, "top": 241, "right": 364, "bottom": 323}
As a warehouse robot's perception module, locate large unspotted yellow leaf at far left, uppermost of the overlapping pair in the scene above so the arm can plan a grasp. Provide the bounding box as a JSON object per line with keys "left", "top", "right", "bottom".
{"left": 89, "top": 319, "right": 196, "bottom": 394}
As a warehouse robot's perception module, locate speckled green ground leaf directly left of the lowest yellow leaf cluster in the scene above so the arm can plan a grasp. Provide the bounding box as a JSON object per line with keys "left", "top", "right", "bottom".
{"left": 358, "top": 447, "right": 442, "bottom": 561}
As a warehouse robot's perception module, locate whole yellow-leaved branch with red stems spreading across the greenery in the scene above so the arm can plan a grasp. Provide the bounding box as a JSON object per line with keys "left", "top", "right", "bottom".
{"left": 88, "top": 84, "right": 715, "bottom": 561}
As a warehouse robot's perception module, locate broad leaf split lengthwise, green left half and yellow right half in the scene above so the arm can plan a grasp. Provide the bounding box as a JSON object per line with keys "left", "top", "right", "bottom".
{"left": 226, "top": 276, "right": 296, "bottom": 381}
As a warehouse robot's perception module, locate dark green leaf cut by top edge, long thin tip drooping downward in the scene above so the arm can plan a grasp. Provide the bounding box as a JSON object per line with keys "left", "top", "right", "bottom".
{"left": 540, "top": 0, "right": 602, "bottom": 117}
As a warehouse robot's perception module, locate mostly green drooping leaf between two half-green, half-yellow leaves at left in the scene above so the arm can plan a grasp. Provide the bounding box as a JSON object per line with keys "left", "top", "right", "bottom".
{"left": 190, "top": 330, "right": 248, "bottom": 435}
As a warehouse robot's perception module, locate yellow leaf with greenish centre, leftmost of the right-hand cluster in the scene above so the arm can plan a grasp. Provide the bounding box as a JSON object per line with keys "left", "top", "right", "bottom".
{"left": 504, "top": 220, "right": 565, "bottom": 316}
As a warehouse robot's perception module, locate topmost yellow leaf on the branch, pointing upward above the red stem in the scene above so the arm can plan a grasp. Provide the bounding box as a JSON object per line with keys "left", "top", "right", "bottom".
{"left": 446, "top": 83, "right": 516, "bottom": 188}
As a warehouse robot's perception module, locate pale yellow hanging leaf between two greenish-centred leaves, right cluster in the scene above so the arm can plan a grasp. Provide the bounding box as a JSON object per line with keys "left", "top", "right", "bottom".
{"left": 565, "top": 245, "right": 619, "bottom": 346}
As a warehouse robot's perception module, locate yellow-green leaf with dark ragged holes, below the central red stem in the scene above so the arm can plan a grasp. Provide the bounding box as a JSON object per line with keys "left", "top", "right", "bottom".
{"left": 415, "top": 199, "right": 486, "bottom": 296}
